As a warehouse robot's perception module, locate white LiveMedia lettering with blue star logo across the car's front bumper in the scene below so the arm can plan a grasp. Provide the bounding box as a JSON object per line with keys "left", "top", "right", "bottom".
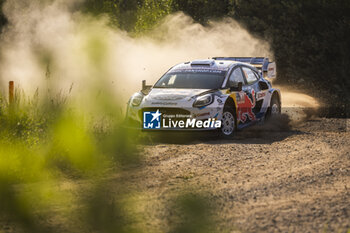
{"left": 143, "top": 109, "right": 221, "bottom": 129}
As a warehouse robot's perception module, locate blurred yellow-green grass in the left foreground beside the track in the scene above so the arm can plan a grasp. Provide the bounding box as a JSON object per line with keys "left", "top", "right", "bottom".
{"left": 0, "top": 88, "right": 216, "bottom": 232}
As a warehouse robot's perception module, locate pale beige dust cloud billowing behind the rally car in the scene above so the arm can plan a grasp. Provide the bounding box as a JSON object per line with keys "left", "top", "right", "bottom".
{"left": 0, "top": 0, "right": 322, "bottom": 117}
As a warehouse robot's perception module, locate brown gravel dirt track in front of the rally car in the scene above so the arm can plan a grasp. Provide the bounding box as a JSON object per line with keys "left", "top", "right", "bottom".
{"left": 129, "top": 119, "right": 350, "bottom": 232}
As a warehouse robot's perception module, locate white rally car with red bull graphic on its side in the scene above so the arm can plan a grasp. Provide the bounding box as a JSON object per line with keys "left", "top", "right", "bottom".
{"left": 126, "top": 57, "right": 281, "bottom": 136}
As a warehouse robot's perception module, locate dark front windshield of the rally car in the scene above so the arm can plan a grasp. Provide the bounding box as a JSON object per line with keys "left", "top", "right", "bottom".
{"left": 154, "top": 70, "right": 226, "bottom": 89}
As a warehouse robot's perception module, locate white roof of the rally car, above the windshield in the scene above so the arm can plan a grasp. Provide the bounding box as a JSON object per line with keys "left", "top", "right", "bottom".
{"left": 169, "top": 59, "right": 255, "bottom": 71}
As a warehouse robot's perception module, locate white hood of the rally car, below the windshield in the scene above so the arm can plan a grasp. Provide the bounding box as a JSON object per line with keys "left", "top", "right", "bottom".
{"left": 147, "top": 88, "right": 210, "bottom": 100}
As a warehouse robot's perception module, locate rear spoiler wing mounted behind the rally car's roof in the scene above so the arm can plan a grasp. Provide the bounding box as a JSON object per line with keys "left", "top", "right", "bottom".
{"left": 213, "top": 57, "right": 277, "bottom": 78}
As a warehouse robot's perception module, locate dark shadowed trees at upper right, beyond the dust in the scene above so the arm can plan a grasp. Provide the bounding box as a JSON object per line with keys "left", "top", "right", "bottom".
{"left": 231, "top": 0, "right": 350, "bottom": 107}
